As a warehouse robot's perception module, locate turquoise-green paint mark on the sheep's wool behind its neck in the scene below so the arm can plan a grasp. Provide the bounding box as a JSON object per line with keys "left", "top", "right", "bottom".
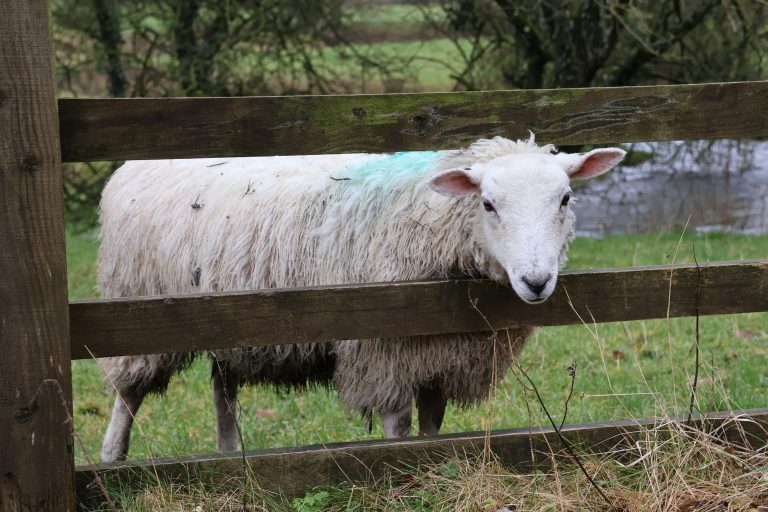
{"left": 344, "top": 151, "right": 444, "bottom": 185}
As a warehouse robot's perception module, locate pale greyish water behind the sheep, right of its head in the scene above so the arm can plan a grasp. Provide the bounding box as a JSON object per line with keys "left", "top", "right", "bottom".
{"left": 574, "top": 140, "right": 768, "bottom": 237}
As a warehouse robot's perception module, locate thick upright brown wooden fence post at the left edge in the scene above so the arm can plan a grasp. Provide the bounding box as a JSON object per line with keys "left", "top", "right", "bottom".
{"left": 0, "top": 0, "right": 75, "bottom": 511}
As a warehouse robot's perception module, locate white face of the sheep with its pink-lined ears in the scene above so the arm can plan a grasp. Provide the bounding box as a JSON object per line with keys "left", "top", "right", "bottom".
{"left": 431, "top": 149, "right": 625, "bottom": 304}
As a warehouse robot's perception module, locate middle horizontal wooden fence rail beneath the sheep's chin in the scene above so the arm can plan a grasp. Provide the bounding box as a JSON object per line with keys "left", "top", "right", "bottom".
{"left": 70, "top": 260, "right": 768, "bottom": 359}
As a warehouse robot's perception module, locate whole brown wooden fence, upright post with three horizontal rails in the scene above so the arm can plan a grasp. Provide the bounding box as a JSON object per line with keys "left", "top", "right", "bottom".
{"left": 0, "top": 0, "right": 768, "bottom": 510}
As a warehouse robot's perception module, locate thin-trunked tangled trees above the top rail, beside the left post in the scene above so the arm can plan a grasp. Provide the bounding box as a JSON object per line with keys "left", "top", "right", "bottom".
{"left": 53, "top": 0, "right": 356, "bottom": 96}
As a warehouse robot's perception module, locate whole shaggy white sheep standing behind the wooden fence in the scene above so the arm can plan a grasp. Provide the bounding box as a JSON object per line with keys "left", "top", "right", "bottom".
{"left": 98, "top": 135, "right": 624, "bottom": 461}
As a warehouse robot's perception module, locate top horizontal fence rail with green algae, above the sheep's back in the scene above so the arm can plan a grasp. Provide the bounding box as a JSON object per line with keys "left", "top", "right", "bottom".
{"left": 59, "top": 82, "right": 768, "bottom": 161}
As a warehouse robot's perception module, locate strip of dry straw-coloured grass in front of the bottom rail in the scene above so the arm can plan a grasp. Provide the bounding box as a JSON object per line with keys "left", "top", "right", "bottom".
{"left": 93, "top": 416, "right": 768, "bottom": 512}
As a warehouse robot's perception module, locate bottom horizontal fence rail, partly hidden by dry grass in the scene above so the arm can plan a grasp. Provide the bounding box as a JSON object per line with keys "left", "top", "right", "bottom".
{"left": 76, "top": 409, "right": 768, "bottom": 504}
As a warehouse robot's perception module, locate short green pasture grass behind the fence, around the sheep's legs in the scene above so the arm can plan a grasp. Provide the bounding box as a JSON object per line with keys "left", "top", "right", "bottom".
{"left": 67, "top": 229, "right": 768, "bottom": 468}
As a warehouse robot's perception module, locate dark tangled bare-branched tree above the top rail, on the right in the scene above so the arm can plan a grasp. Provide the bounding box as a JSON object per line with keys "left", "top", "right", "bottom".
{"left": 424, "top": 0, "right": 768, "bottom": 89}
